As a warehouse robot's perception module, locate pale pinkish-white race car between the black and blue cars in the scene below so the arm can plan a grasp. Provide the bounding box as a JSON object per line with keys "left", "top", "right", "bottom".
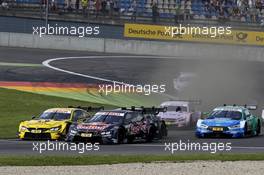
{"left": 158, "top": 101, "right": 202, "bottom": 127}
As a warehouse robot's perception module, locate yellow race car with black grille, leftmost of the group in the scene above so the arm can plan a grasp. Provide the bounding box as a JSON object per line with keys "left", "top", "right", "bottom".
{"left": 18, "top": 107, "right": 101, "bottom": 140}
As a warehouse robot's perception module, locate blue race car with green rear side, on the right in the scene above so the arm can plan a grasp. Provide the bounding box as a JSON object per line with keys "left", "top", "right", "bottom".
{"left": 195, "top": 105, "right": 262, "bottom": 138}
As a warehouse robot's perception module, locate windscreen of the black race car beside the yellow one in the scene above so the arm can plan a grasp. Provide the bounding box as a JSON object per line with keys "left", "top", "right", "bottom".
{"left": 87, "top": 114, "right": 124, "bottom": 124}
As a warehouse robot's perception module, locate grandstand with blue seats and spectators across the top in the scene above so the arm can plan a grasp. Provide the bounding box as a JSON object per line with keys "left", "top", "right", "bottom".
{"left": 0, "top": 0, "right": 264, "bottom": 25}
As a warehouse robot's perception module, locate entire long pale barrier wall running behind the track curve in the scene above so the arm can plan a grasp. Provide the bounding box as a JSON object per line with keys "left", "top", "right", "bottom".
{"left": 0, "top": 32, "right": 264, "bottom": 61}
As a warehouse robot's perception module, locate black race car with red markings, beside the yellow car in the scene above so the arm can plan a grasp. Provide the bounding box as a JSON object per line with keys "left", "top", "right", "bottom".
{"left": 66, "top": 107, "right": 167, "bottom": 144}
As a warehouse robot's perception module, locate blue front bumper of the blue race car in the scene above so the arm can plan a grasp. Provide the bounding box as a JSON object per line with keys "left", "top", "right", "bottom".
{"left": 195, "top": 128, "right": 244, "bottom": 138}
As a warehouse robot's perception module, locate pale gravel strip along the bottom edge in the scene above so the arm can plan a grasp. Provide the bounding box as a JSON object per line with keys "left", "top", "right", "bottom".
{"left": 0, "top": 161, "right": 264, "bottom": 175}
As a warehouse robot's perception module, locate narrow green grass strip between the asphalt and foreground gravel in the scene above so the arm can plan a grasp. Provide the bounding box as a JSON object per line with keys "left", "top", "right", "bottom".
{"left": 0, "top": 153, "right": 264, "bottom": 166}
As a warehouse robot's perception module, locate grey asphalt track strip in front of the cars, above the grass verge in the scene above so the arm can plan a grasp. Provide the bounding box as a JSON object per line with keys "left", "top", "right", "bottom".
{"left": 0, "top": 129, "right": 264, "bottom": 155}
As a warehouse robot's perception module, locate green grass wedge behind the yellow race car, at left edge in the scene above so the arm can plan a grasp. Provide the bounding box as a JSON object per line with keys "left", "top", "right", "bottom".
{"left": 0, "top": 88, "right": 114, "bottom": 138}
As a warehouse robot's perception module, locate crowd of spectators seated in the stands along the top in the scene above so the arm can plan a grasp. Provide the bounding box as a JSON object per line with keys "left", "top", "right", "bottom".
{"left": 0, "top": 0, "right": 264, "bottom": 25}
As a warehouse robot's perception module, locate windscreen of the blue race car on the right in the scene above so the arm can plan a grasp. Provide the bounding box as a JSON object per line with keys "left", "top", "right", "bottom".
{"left": 208, "top": 110, "right": 242, "bottom": 120}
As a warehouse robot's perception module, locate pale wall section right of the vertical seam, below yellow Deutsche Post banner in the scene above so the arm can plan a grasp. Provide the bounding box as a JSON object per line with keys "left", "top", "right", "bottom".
{"left": 105, "top": 39, "right": 264, "bottom": 61}
